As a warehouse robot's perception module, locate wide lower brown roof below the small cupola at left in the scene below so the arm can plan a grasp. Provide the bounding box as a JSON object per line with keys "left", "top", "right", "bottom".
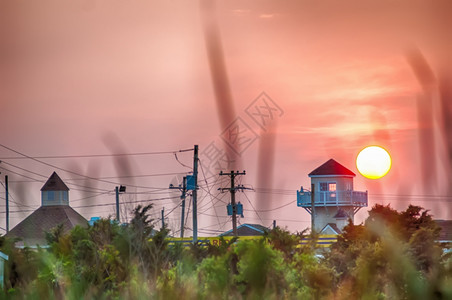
{"left": 6, "top": 205, "right": 88, "bottom": 247}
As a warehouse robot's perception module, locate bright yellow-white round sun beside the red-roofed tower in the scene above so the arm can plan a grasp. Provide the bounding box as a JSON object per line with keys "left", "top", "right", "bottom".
{"left": 356, "top": 146, "right": 391, "bottom": 179}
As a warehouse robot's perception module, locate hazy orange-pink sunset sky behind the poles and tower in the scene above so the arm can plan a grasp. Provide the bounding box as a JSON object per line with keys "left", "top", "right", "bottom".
{"left": 0, "top": 0, "right": 452, "bottom": 234}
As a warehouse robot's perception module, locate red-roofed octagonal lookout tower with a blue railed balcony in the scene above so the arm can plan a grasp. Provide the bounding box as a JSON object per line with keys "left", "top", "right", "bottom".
{"left": 297, "top": 159, "right": 367, "bottom": 233}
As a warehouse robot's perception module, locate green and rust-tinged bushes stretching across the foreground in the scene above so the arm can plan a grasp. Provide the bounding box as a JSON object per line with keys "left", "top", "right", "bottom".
{"left": 0, "top": 205, "right": 452, "bottom": 299}
